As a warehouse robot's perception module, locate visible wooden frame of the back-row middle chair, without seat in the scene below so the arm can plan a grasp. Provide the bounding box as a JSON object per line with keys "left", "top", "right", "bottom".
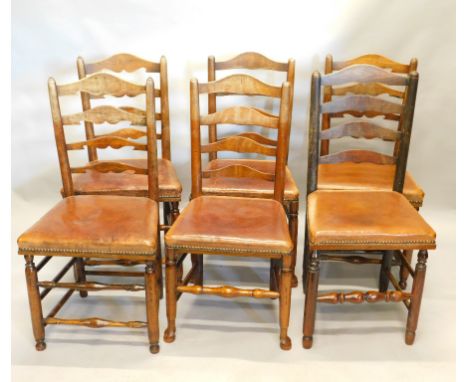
{"left": 208, "top": 52, "right": 299, "bottom": 287}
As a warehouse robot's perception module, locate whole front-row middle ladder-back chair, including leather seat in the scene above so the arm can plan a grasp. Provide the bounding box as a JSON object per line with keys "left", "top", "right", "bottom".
{"left": 164, "top": 75, "right": 294, "bottom": 350}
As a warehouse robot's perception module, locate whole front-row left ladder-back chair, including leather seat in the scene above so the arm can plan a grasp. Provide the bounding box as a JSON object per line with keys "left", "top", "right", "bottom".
{"left": 18, "top": 74, "right": 161, "bottom": 353}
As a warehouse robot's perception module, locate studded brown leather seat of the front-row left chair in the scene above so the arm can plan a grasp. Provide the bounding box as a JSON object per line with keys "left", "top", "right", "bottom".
{"left": 18, "top": 195, "right": 158, "bottom": 257}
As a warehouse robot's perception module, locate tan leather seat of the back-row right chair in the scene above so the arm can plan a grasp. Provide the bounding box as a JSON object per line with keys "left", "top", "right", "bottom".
{"left": 318, "top": 162, "right": 424, "bottom": 207}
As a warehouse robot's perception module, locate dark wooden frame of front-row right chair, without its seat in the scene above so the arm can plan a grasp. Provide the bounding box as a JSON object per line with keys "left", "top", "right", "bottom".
{"left": 303, "top": 65, "right": 435, "bottom": 348}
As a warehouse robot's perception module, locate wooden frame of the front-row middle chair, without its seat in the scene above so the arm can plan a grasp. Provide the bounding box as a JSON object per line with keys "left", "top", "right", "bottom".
{"left": 164, "top": 75, "right": 292, "bottom": 350}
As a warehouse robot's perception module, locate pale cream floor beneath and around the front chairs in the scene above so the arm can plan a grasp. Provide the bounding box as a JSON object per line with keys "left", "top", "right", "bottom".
{"left": 11, "top": 194, "right": 455, "bottom": 382}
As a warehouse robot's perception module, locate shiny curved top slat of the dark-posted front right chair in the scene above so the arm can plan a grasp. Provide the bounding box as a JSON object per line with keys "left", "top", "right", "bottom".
{"left": 322, "top": 65, "right": 408, "bottom": 86}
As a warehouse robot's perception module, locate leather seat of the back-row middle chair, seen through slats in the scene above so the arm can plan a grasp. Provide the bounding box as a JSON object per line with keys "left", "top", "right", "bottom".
{"left": 202, "top": 159, "right": 299, "bottom": 201}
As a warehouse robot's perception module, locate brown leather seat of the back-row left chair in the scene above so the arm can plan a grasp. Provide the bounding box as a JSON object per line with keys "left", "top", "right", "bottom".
{"left": 73, "top": 159, "right": 182, "bottom": 201}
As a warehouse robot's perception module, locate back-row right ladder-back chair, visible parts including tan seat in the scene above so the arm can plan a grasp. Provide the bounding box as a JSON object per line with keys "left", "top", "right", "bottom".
{"left": 318, "top": 54, "right": 424, "bottom": 289}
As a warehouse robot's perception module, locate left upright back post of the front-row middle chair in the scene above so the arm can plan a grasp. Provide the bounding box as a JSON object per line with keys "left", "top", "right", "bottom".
{"left": 190, "top": 78, "right": 202, "bottom": 199}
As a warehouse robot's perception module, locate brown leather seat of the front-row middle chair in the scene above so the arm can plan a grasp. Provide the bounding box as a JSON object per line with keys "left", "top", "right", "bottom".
{"left": 165, "top": 196, "right": 293, "bottom": 255}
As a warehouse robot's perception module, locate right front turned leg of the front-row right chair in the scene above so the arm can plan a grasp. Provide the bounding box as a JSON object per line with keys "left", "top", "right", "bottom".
{"left": 405, "top": 250, "right": 427, "bottom": 345}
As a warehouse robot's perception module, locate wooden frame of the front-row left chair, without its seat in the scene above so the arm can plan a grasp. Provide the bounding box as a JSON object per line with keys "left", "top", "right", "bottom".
{"left": 19, "top": 74, "right": 162, "bottom": 353}
